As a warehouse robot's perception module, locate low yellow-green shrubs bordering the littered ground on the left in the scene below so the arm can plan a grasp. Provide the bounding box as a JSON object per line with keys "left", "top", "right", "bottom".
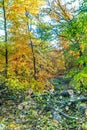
{"left": 3, "top": 76, "right": 44, "bottom": 94}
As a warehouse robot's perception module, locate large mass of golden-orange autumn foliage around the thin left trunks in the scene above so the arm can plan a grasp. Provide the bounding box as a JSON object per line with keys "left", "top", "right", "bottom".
{"left": 0, "top": 0, "right": 64, "bottom": 92}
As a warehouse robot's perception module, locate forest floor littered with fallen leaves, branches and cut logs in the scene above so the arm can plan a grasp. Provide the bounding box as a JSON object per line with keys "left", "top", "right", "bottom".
{"left": 0, "top": 78, "right": 87, "bottom": 130}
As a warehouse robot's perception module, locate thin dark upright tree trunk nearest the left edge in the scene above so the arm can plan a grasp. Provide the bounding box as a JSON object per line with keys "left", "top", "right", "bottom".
{"left": 3, "top": 0, "right": 8, "bottom": 78}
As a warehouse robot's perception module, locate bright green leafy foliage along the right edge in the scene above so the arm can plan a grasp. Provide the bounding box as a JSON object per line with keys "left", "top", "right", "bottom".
{"left": 61, "top": 3, "right": 87, "bottom": 91}
